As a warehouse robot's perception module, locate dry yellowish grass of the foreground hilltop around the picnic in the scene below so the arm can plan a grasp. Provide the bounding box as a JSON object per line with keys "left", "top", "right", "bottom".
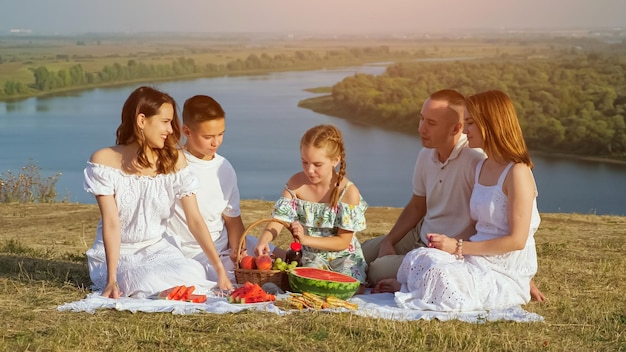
{"left": 0, "top": 201, "right": 626, "bottom": 351}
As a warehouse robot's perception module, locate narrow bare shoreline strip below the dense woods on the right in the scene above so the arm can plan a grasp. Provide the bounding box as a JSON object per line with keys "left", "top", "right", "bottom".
{"left": 298, "top": 93, "right": 626, "bottom": 165}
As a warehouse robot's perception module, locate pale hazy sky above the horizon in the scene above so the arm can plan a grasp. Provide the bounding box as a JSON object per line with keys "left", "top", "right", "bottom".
{"left": 0, "top": 0, "right": 626, "bottom": 34}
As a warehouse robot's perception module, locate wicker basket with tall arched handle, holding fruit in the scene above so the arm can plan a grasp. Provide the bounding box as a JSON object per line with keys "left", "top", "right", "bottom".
{"left": 235, "top": 218, "right": 291, "bottom": 291}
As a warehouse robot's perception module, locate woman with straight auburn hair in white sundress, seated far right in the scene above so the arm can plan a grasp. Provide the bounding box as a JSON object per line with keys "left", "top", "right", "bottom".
{"left": 375, "top": 91, "right": 540, "bottom": 312}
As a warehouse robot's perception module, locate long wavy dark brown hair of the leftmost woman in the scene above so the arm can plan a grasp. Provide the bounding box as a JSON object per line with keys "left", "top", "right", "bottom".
{"left": 115, "top": 87, "right": 180, "bottom": 174}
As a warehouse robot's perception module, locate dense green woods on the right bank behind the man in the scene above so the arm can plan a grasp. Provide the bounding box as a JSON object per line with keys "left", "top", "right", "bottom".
{"left": 332, "top": 54, "right": 626, "bottom": 159}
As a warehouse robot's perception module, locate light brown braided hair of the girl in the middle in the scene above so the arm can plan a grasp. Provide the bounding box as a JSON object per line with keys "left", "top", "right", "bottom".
{"left": 300, "top": 125, "right": 346, "bottom": 207}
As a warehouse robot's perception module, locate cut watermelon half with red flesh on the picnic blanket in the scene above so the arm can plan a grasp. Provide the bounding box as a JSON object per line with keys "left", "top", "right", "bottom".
{"left": 288, "top": 267, "right": 361, "bottom": 299}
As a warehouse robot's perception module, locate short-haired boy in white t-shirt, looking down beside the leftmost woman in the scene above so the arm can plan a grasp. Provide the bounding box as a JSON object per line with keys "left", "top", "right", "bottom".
{"left": 168, "top": 95, "right": 272, "bottom": 281}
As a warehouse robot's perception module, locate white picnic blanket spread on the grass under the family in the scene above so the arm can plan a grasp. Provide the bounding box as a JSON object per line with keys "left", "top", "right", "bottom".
{"left": 57, "top": 292, "right": 543, "bottom": 323}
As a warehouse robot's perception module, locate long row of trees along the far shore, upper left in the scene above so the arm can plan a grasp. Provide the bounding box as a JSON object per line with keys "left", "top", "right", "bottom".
{"left": 0, "top": 46, "right": 412, "bottom": 97}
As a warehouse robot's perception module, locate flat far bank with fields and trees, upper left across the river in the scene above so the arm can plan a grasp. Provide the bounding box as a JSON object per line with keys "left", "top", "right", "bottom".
{"left": 0, "top": 34, "right": 442, "bottom": 101}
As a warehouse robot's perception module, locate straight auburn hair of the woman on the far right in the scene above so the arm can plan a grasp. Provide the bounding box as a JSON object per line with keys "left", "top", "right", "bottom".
{"left": 467, "top": 90, "right": 533, "bottom": 169}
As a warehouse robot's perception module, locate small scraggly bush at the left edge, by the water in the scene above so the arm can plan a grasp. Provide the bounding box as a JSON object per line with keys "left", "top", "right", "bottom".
{"left": 0, "top": 163, "right": 61, "bottom": 203}
